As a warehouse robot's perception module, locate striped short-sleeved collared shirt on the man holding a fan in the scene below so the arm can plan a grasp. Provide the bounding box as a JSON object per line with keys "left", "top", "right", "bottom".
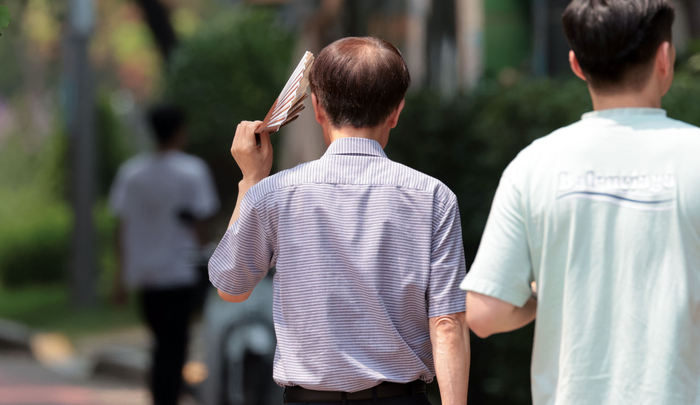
{"left": 209, "top": 138, "right": 466, "bottom": 392}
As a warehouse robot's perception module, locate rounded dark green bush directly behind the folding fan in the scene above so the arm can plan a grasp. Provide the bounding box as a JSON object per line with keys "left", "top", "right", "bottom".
{"left": 166, "top": 8, "right": 301, "bottom": 211}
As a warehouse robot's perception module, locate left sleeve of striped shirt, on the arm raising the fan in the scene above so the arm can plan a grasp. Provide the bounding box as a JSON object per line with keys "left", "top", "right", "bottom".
{"left": 209, "top": 193, "right": 273, "bottom": 295}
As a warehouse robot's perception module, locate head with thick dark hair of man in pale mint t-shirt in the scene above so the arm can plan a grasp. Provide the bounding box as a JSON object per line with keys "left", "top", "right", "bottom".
{"left": 563, "top": 0, "right": 675, "bottom": 95}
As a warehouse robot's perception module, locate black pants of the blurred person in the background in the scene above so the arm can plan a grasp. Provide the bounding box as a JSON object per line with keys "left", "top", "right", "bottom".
{"left": 141, "top": 287, "right": 194, "bottom": 405}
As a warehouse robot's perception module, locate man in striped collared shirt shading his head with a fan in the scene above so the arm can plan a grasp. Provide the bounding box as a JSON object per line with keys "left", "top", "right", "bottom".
{"left": 209, "top": 38, "right": 469, "bottom": 404}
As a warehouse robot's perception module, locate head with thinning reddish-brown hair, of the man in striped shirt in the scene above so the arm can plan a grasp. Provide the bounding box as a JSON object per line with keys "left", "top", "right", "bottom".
{"left": 309, "top": 37, "right": 411, "bottom": 144}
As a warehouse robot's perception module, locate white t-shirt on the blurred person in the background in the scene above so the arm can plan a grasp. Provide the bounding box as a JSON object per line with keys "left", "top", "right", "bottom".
{"left": 110, "top": 151, "right": 219, "bottom": 288}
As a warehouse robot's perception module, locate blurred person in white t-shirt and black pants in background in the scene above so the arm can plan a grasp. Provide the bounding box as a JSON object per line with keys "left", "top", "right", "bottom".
{"left": 110, "top": 105, "right": 219, "bottom": 405}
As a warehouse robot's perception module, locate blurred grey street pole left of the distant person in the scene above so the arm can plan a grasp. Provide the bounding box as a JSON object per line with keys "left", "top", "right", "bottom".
{"left": 64, "top": 0, "right": 97, "bottom": 308}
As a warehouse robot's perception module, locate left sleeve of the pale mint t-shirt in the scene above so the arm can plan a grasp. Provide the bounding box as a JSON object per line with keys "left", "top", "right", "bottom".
{"left": 460, "top": 164, "right": 533, "bottom": 307}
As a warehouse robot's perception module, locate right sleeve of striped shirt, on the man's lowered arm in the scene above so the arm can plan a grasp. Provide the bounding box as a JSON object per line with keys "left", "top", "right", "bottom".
{"left": 427, "top": 198, "right": 466, "bottom": 318}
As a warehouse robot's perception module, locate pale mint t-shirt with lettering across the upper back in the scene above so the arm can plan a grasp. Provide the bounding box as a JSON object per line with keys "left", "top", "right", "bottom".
{"left": 462, "top": 109, "right": 700, "bottom": 405}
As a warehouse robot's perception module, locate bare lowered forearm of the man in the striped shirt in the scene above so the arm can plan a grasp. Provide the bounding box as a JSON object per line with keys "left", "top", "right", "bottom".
{"left": 430, "top": 312, "right": 471, "bottom": 405}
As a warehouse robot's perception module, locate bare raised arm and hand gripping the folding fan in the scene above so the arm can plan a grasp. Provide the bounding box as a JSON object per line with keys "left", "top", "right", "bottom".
{"left": 218, "top": 121, "right": 272, "bottom": 302}
